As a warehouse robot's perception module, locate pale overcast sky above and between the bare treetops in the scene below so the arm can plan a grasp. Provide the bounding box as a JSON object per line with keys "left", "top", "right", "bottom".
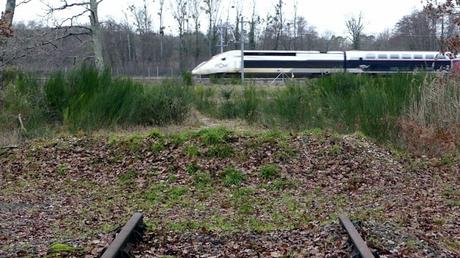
{"left": 7, "top": 0, "right": 422, "bottom": 35}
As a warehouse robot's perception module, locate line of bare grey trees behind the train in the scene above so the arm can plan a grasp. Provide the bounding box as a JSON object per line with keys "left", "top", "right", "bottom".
{"left": 1, "top": 0, "right": 459, "bottom": 76}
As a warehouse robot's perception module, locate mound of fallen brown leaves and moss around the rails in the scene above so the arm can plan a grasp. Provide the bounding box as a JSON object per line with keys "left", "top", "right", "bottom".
{"left": 0, "top": 134, "right": 460, "bottom": 257}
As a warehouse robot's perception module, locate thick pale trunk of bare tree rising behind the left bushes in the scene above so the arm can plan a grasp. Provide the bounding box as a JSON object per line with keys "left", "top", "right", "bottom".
{"left": 90, "top": 0, "right": 104, "bottom": 71}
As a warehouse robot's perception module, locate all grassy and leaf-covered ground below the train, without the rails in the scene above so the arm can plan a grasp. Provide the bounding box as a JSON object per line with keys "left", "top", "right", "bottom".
{"left": 0, "top": 67, "right": 460, "bottom": 257}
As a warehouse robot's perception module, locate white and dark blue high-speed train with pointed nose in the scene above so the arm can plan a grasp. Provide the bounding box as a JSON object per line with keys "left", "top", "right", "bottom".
{"left": 192, "top": 50, "right": 460, "bottom": 77}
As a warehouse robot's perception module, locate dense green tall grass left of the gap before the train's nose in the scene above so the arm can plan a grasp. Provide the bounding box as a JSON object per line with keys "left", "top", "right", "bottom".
{"left": 0, "top": 66, "right": 192, "bottom": 137}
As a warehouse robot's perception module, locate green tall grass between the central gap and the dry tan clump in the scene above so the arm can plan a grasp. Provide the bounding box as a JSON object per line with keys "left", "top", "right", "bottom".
{"left": 195, "top": 74, "right": 425, "bottom": 140}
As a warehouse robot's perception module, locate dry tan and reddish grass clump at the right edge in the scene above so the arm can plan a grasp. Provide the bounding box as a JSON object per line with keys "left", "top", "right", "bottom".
{"left": 400, "top": 77, "right": 460, "bottom": 155}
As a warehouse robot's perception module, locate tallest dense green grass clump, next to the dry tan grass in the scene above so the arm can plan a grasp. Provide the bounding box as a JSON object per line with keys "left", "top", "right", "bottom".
{"left": 317, "top": 74, "right": 424, "bottom": 140}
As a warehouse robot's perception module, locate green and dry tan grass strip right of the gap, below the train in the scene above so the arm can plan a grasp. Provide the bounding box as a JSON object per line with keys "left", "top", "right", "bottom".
{"left": 194, "top": 74, "right": 460, "bottom": 155}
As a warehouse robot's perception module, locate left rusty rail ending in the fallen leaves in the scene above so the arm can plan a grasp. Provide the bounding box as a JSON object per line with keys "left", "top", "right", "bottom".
{"left": 101, "top": 213, "right": 145, "bottom": 258}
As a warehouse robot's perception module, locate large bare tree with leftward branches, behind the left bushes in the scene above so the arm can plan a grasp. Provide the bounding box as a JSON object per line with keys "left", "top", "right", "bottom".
{"left": 49, "top": 0, "right": 104, "bottom": 70}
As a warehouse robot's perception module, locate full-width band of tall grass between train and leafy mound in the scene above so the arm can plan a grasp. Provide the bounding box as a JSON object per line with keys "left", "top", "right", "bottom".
{"left": 0, "top": 66, "right": 460, "bottom": 155}
